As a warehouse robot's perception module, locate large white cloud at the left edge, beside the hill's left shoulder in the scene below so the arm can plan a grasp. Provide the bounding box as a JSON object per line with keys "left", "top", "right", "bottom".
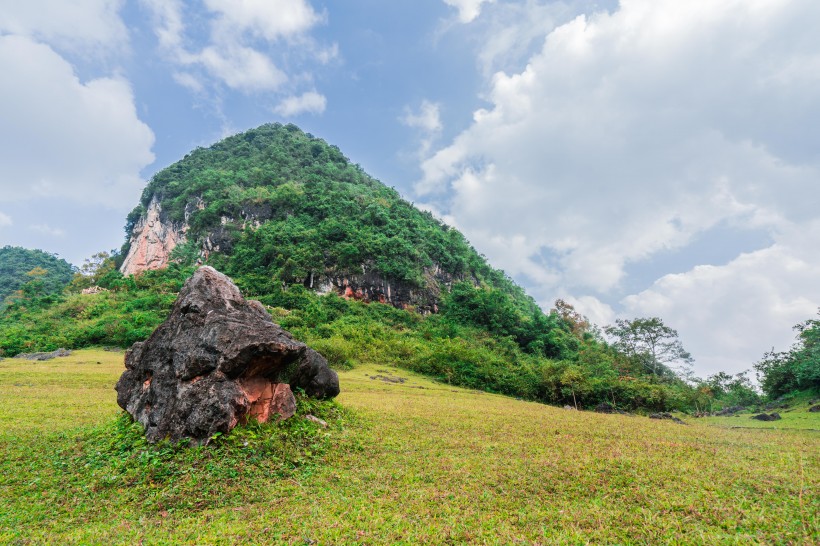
{"left": 0, "top": 36, "right": 154, "bottom": 208}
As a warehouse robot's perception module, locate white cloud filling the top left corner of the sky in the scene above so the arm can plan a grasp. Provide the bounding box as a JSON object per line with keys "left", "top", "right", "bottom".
{"left": 0, "top": 0, "right": 128, "bottom": 54}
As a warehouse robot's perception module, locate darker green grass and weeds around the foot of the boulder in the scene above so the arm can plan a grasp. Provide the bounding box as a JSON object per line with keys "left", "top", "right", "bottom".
{"left": 52, "top": 394, "right": 352, "bottom": 510}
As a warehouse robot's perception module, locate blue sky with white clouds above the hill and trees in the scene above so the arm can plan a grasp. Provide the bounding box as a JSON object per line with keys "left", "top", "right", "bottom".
{"left": 0, "top": 0, "right": 820, "bottom": 377}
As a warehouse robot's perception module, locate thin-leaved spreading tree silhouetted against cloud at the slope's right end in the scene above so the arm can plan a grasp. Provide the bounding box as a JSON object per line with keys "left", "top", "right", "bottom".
{"left": 604, "top": 317, "right": 693, "bottom": 376}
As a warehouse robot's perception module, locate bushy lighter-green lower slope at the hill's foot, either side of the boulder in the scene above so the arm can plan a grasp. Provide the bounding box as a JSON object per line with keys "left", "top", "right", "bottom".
{"left": 0, "top": 259, "right": 756, "bottom": 410}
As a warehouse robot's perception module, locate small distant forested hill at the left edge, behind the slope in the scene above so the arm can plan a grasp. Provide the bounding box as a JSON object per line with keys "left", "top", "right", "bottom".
{"left": 0, "top": 246, "right": 74, "bottom": 308}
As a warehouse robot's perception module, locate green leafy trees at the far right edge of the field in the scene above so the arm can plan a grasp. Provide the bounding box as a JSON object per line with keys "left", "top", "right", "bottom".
{"left": 754, "top": 310, "right": 820, "bottom": 398}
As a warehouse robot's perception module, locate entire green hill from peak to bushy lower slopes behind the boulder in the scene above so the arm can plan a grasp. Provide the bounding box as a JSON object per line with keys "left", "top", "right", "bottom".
{"left": 0, "top": 124, "right": 724, "bottom": 411}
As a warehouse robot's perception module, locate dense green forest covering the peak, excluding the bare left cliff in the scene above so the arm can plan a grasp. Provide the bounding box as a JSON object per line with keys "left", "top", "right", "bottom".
{"left": 124, "top": 124, "right": 502, "bottom": 299}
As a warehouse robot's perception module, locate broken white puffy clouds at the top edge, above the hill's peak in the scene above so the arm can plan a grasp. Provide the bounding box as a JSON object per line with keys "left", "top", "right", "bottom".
{"left": 142, "top": 0, "right": 328, "bottom": 94}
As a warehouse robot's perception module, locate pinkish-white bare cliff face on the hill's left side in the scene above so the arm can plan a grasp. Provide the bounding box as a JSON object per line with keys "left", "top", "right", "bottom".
{"left": 120, "top": 196, "right": 187, "bottom": 275}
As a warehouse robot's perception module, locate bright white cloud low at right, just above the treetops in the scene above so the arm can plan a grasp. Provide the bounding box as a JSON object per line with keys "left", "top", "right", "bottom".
{"left": 624, "top": 221, "right": 820, "bottom": 374}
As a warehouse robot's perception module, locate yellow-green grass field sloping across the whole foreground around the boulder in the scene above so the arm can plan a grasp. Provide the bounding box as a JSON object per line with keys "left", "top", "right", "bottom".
{"left": 0, "top": 350, "right": 820, "bottom": 544}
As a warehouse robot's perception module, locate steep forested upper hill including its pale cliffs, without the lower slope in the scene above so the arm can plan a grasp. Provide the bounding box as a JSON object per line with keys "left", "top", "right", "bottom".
{"left": 123, "top": 124, "right": 572, "bottom": 356}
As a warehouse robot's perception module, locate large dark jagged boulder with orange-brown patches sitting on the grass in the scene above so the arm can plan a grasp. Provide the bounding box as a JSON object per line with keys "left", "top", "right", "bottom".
{"left": 116, "top": 266, "right": 339, "bottom": 442}
